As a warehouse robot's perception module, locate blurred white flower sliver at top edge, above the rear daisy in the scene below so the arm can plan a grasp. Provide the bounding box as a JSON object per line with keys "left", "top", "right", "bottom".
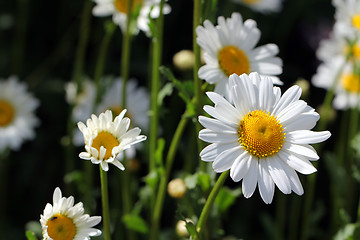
{"left": 233, "top": 0, "right": 282, "bottom": 13}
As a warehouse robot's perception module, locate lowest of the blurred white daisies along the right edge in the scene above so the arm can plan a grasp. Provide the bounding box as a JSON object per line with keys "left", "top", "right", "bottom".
{"left": 311, "top": 57, "right": 360, "bottom": 110}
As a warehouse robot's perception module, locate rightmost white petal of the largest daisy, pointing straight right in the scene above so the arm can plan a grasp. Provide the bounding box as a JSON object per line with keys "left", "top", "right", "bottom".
{"left": 286, "top": 130, "right": 331, "bottom": 144}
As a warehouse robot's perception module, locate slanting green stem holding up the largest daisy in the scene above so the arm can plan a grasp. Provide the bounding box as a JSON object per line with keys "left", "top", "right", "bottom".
{"left": 194, "top": 170, "right": 230, "bottom": 240}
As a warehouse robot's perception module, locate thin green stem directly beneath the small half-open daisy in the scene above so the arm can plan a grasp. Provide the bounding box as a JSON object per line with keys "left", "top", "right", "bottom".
{"left": 99, "top": 165, "right": 111, "bottom": 240}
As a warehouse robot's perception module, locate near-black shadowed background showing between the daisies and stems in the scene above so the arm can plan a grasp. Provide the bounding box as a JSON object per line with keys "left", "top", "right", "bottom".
{"left": 0, "top": 0, "right": 344, "bottom": 240}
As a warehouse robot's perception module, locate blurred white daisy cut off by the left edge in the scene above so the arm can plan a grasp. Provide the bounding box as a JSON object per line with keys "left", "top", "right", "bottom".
{"left": 0, "top": 76, "right": 39, "bottom": 152}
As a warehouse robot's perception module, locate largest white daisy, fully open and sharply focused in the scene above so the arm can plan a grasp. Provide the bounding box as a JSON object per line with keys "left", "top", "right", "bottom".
{"left": 199, "top": 73, "right": 330, "bottom": 204}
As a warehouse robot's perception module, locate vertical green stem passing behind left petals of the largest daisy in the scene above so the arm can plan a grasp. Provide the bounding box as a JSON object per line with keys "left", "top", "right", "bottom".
{"left": 193, "top": 0, "right": 206, "bottom": 171}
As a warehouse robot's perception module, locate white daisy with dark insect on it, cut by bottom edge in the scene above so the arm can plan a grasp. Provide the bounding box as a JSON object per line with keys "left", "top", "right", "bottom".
{"left": 40, "top": 187, "right": 101, "bottom": 240}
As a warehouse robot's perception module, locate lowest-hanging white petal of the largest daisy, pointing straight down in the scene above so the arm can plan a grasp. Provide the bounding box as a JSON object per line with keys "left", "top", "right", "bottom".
{"left": 258, "top": 161, "right": 275, "bottom": 204}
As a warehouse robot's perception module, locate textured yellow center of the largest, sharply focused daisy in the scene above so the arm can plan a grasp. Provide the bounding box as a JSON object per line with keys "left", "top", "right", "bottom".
{"left": 238, "top": 110, "right": 285, "bottom": 158}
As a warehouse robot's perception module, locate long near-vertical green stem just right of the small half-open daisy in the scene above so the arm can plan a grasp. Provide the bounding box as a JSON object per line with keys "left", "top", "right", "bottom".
{"left": 149, "top": 0, "right": 165, "bottom": 172}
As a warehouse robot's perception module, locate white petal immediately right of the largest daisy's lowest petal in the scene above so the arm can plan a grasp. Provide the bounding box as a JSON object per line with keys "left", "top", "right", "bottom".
{"left": 268, "top": 157, "right": 291, "bottom": 194}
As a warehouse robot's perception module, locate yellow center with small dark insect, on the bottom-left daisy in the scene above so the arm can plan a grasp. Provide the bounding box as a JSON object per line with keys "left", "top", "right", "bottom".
{"left": 46, "top": 214, "right": 76, "bottom": 240}
